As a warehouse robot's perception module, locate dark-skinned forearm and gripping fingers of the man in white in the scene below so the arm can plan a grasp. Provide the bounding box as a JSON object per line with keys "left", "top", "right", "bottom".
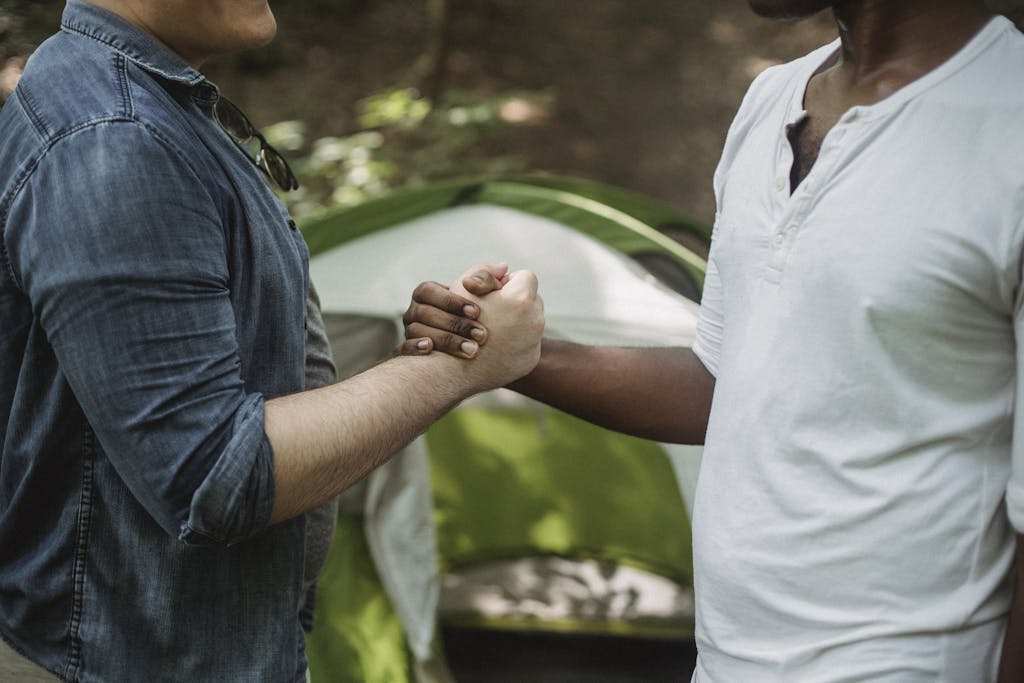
{"left": 401, "top": 268, "right": 715, "bottom": 443}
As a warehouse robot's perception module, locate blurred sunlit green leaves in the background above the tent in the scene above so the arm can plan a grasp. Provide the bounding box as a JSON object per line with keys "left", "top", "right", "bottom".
{"left": 263, "top": 88, "right": 552, "bottom": 218}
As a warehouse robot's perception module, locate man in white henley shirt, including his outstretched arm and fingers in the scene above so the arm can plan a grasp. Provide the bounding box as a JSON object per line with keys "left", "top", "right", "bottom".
{"left": 407, "top": 0, "right": 1024, "bottom": 683}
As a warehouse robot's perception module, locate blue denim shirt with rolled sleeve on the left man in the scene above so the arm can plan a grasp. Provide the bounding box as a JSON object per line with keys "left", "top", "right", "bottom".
{"left": 0, "top": 0, "right": 308, "bottom": 682}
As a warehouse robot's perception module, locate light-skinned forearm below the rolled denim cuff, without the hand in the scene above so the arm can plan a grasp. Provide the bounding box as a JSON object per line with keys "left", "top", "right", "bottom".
{"left": 264, "top": 354, "right": 472, "bottom": 523}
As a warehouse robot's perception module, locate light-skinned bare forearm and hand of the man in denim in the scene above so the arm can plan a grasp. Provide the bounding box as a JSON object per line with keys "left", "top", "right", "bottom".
{"left": 264, "top": 271, "right": 544, "bottom": 523}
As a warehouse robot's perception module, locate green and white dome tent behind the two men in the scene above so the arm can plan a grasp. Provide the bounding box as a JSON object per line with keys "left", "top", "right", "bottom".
{"left": 302, "top": 177, "right": 708, "bottom": 683}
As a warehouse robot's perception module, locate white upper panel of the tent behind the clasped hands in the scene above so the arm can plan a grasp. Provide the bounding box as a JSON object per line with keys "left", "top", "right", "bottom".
{"left": 310, "top": 205, "right": 697, "bottom": 346}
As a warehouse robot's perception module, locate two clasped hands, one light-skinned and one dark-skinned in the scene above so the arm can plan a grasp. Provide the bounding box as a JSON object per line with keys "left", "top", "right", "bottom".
{"left": 398, "top": 264, "right": 544, "bottom": 391}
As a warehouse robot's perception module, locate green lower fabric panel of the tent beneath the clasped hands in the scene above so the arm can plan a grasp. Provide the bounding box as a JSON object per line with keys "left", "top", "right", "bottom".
{"left": 426, "top": 401, "right": 693, "bottom": 586}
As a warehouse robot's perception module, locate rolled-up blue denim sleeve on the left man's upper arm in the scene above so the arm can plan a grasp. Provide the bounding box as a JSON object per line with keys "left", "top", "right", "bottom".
{"left": 6, "top": 122, "right": 273, "bottom": 544}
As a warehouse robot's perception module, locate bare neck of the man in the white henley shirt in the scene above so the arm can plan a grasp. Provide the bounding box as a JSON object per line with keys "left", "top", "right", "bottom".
{"left": 833, "top": 0, "right": 992, "bottom": 88}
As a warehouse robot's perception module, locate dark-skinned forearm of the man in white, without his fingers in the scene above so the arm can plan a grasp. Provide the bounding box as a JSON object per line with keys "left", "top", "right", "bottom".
{"left": 510, "top": 339, "right": 715, "bottom": 443}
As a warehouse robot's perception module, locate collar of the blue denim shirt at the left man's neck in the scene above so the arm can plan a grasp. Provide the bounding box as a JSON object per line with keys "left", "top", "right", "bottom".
{"left": 60, "top": 0, "right": 206, "bottom": 86}
